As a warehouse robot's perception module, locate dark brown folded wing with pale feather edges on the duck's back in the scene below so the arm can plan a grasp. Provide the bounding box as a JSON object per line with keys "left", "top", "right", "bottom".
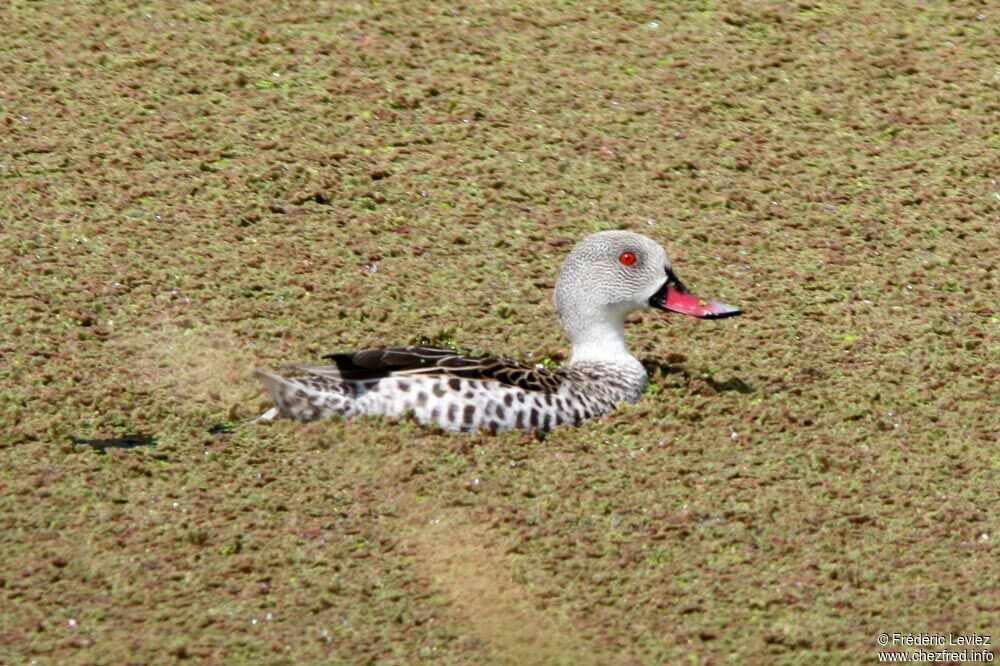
{"left": 323, "top": 346, "right": 564, "bottom": 393}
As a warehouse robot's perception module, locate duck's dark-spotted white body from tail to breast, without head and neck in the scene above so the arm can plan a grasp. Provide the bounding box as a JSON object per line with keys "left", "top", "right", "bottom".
{"left": 257, "top": 347, "right": 646, "bottom": 432}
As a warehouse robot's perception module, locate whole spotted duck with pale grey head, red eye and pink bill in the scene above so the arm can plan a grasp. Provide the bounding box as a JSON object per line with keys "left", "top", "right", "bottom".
{"left": 255, "top": 231, "right": 741, "bottom": 434}
